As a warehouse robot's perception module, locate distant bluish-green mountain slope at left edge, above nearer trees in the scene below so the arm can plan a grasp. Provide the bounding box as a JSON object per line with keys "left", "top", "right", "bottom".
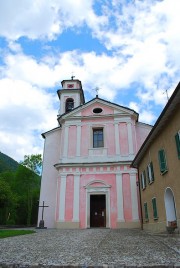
{"left": 0, "top": 152, "right": 19, "bottom": 173}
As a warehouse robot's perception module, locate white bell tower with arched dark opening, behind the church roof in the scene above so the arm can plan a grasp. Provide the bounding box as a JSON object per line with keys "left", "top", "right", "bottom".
{"left": 57, "top": 76, "right": 85, "bottom": 115}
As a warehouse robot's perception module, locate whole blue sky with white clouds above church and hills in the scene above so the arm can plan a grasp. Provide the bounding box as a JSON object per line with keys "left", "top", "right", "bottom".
{"left": 0, "top": 0, "right": 180, "bottom": 161}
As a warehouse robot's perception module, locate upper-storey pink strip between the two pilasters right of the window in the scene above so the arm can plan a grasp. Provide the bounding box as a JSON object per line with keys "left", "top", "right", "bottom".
{"left": 119, "top": 123, "right": 129, "bottom": 155}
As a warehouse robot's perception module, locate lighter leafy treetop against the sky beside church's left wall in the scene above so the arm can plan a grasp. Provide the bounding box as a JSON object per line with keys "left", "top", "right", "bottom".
{"left": 20, "top": 154, "right": 42, "bottom": 175}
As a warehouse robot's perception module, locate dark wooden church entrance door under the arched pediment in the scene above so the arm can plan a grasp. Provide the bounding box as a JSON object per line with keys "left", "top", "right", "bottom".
{"left": 90, "top": 194, "right": 106, "bottom": 227}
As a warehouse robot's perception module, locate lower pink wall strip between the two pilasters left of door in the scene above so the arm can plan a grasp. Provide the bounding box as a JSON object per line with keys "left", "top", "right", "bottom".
{"left": 65, "top": 175, "right": 74, "bottom": 221}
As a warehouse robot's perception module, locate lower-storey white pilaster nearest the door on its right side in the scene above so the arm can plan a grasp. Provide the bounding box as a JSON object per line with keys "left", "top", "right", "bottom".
{"left": 116, "top": 174, "right": 124, "bottom": 222}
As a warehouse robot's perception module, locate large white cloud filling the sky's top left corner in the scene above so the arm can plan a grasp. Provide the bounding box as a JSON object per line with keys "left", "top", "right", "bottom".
{"left": 0, "top": 0, "right": 104, "bottom": 40}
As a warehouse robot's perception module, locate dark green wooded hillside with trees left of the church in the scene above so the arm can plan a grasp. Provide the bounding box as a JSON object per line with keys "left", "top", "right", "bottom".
{"left": 0, "top": 153, "right": 42, "bottom": 226}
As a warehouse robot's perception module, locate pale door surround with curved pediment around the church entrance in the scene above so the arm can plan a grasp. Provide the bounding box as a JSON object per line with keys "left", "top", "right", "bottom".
{"left": 84, "top": 180, "right": 111, "bottom": 228}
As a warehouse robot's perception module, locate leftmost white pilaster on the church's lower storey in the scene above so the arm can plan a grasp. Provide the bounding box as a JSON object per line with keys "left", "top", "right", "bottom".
{"left": 59, "top": 175, "right": 66, "bottom": 221}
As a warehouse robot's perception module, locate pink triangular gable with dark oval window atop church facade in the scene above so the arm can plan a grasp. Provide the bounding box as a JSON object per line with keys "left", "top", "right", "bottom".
{"left": 60, "top": 98, "right": 138, "bottom": 119}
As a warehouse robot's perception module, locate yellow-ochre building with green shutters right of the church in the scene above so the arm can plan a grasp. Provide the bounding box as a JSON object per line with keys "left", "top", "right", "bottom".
{"left": 132, "top": 83, "right": 180, "bottom": 232}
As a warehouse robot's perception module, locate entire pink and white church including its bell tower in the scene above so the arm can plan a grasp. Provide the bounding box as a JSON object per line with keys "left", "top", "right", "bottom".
{"left": 38, "top": 77, "right": 152, "bottom": 229}
